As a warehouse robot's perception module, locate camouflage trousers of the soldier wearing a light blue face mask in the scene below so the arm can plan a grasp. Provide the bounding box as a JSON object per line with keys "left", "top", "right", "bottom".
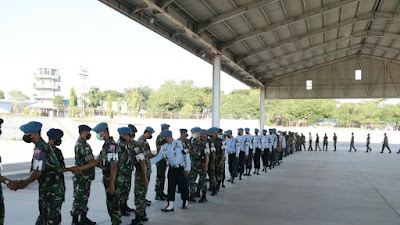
{"left": 103, "top": 180, "right": 122, "bottom": 225}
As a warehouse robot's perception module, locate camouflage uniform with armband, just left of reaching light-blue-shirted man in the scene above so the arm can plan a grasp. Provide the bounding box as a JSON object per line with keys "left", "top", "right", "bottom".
{"left": 128, "top": 138, "right": 150, "bottom": 216}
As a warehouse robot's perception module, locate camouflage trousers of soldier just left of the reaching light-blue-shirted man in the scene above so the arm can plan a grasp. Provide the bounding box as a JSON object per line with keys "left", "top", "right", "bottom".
{"left": 134, "top": 168, "right": 150, "bottom": 216}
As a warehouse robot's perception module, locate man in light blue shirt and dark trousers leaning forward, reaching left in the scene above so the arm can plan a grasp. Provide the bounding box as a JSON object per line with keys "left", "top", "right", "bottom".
{"left": 150, "top": 130, "right": 191, "bottom": 212}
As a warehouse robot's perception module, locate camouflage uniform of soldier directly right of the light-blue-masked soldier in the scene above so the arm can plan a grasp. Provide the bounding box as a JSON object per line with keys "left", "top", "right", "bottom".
{"left": 118, "top": 139, "right": 133, "bottom": 204}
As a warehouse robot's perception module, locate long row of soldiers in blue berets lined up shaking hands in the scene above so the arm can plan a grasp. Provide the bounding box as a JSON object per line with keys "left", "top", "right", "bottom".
{"left": 0, "top": 119, "right": 302, "bottom": 225}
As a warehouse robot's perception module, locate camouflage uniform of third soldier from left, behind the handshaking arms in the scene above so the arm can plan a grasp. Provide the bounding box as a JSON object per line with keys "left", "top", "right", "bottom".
{"left": 71, "top": 137, "right": 95, "bottom": 216}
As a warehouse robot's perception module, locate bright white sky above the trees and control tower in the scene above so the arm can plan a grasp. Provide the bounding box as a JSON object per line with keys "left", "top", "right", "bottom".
{"left": 0, "top": 0, "right": 248, "bottom": 97}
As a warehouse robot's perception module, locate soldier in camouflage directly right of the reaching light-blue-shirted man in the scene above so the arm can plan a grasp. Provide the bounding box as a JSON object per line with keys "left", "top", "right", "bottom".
{"left": 189, "top": 127, "right": 210, "bottom": 203}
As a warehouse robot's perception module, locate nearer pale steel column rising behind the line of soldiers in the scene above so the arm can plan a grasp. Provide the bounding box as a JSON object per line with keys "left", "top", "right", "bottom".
{"left": 212, "top": 54, "right": 221, "bottom": 127}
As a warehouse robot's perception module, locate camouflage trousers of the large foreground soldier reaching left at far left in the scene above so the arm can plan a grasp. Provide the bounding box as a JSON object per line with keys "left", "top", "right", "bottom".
{"left": 36, "top": 183, "right": 64, "bottom": 225}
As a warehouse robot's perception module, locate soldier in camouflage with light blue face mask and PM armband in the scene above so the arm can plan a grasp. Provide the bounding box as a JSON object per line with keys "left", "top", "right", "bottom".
{"left": 78, "top": 123, "right": 122, "bottom": 225}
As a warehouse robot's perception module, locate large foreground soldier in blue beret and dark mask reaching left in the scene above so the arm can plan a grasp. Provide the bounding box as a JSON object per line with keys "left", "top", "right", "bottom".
{"left": 16, "top": 121, "right": 70, "bottom": 225}
